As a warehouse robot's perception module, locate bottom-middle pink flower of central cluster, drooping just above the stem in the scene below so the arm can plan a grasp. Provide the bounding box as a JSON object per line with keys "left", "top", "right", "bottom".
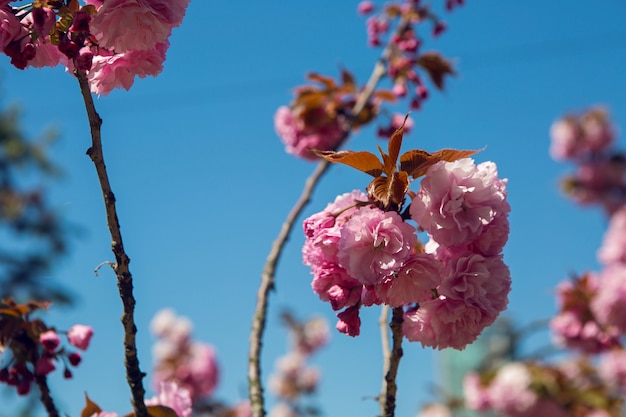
{"left": 376, "top": 253, "right": 442, "bottom": 307}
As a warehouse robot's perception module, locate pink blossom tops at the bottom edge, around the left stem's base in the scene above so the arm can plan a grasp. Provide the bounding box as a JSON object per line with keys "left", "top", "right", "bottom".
{"left": 81, "top": 382, "right": 193, "bottom": 417}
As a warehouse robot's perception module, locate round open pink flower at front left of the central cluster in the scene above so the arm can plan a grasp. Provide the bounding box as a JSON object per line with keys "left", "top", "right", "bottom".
{"left": 337, "top": 207, "right": 417, "bottom": 285}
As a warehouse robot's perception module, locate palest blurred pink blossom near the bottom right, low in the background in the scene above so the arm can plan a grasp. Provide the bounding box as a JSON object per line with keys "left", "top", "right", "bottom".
{"left": 488, "top": 362, "right": 537, "bottom": 416}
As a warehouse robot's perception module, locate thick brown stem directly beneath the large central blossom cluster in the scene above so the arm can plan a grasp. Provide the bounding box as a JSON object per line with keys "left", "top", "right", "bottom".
{"left": 379, "top": 307, "right": 404, "bottom": 417}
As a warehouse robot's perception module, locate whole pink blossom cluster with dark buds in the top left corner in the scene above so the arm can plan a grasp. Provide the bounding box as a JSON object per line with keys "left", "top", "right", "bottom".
{"left": 0, "top": 0, "right": 189, "bottom": 95}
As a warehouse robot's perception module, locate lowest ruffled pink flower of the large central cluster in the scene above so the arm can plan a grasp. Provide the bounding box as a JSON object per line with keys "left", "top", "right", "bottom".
{"left": 402, "top": 295, "right": 496, "bottom": 349}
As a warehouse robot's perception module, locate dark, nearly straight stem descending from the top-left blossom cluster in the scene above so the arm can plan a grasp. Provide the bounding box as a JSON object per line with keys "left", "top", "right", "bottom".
{"left": 75, "top": 71, "right": 148, "bottom": 417}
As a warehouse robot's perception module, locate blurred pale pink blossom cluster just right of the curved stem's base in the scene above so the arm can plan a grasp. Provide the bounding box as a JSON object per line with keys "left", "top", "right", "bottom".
{"left": 269, "top": 313, "right": 329, "bottom": 417}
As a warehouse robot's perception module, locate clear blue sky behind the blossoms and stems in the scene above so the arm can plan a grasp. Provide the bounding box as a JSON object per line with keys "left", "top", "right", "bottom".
{"left": 0, "top": 0, "right": 626, "bottom": 416}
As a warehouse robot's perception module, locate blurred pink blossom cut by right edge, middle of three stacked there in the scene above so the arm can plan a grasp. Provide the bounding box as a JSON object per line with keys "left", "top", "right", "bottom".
{"left": 591, "top": 264, "right": 626, "bottom": 333}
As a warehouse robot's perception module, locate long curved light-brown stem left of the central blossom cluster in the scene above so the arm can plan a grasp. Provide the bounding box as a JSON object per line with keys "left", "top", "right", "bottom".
{"left": 248, "top": 16, "right": 407, "bottom": 417}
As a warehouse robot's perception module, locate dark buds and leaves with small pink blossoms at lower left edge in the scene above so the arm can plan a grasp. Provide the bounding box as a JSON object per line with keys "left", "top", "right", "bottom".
{"left": 0, "top": 299, "right": 93, "bottom": 395}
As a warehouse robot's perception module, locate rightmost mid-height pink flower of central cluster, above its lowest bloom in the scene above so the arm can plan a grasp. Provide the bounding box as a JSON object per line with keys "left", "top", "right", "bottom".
{"left": 438, "top": 254, "right": 511, "bottom": 316}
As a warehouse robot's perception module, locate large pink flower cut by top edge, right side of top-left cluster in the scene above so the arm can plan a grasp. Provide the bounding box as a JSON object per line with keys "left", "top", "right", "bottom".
{"left": 90, "top": 0, "right": 189, "bottom": 53}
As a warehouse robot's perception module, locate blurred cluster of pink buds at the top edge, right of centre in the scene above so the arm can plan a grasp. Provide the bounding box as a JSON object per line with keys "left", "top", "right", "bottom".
{"left": 358, "top": 0, "right": 456, "bottom": 110}
